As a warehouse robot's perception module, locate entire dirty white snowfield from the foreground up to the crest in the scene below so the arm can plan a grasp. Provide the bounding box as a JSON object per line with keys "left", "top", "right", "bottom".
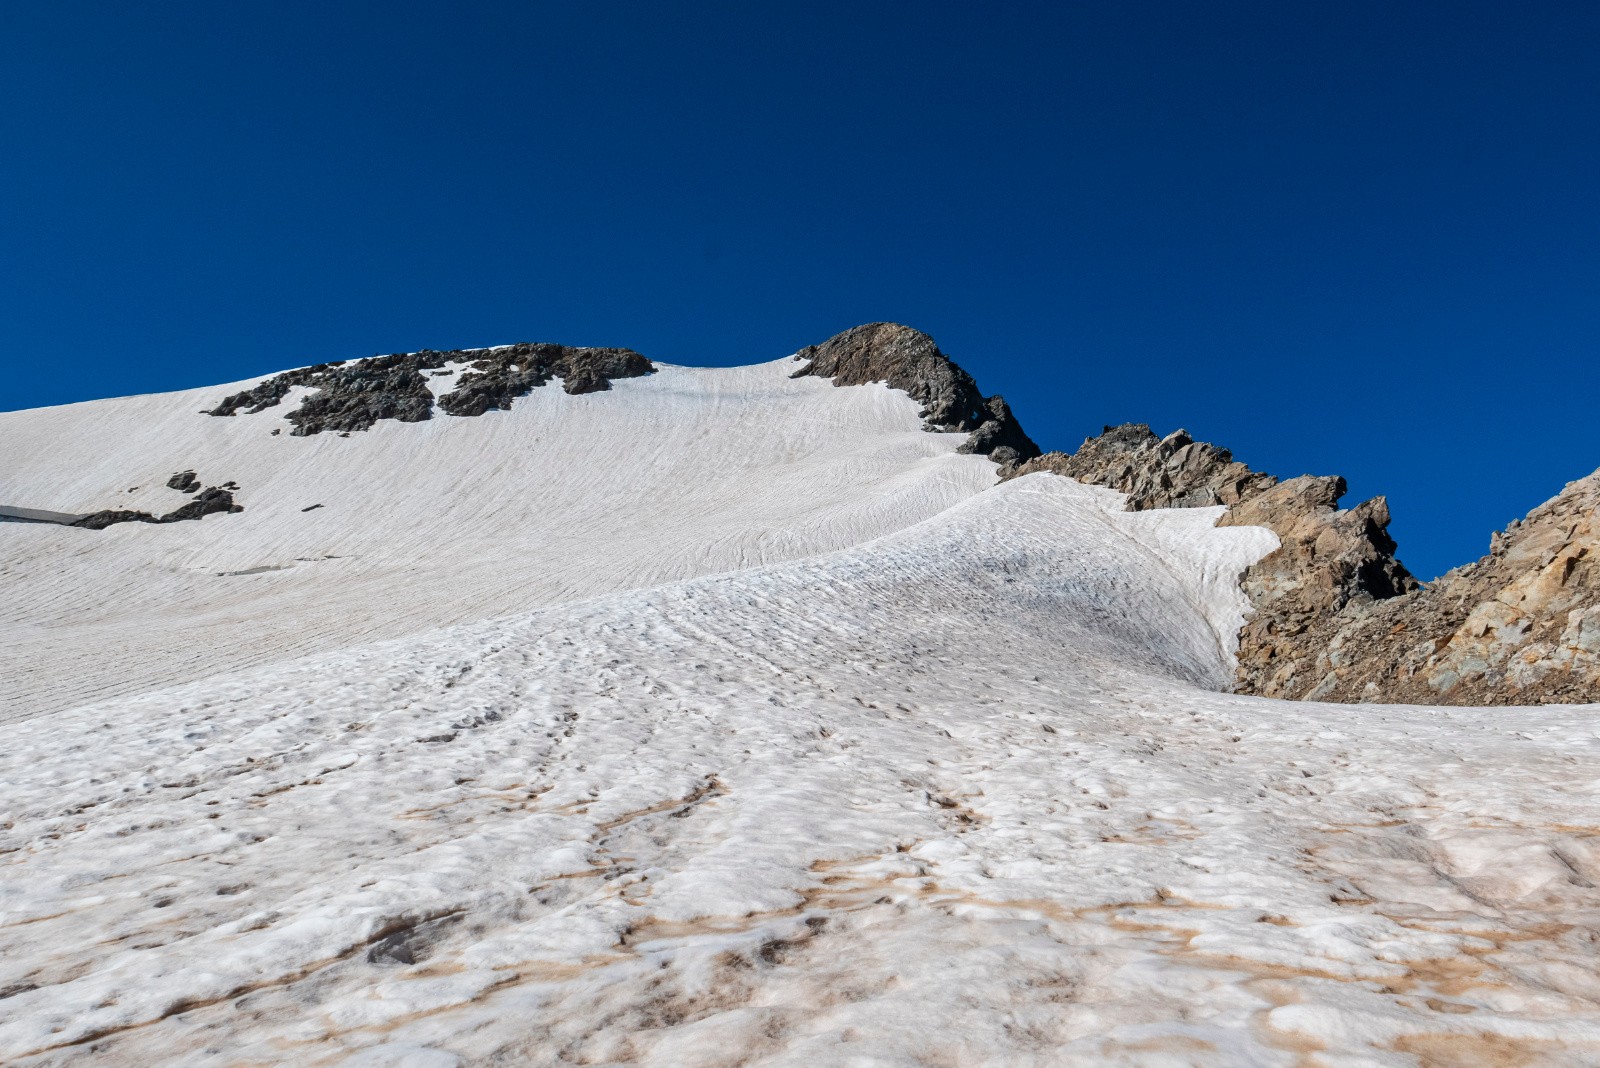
{"left": 0, "top": 361, "right": 1600, "bottom": 1068}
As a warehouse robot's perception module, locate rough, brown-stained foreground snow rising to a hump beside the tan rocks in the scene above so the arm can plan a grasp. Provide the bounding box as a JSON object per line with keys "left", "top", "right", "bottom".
{"left": 0, "top": 475, "right": 1600, "bottom": 1066}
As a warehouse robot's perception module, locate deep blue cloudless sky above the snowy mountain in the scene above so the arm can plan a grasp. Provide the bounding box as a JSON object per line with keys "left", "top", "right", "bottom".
{"left": 0, "top": 0, "right": 1600, "bottom": 577}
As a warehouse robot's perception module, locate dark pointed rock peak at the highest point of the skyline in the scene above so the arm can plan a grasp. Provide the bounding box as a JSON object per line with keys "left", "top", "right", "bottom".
{"left": 790, "top": 323, "right": 1038, "bottom": 468}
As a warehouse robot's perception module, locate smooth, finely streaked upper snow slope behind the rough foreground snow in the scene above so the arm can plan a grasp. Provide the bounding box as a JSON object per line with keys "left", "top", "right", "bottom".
{"left": 0, "top": 360, "right": 994, "bottom": 721}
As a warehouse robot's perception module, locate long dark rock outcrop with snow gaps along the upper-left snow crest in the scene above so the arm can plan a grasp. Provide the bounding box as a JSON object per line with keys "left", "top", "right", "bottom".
{"left": 206, "top": 344, "right": 654, "bottom": 436}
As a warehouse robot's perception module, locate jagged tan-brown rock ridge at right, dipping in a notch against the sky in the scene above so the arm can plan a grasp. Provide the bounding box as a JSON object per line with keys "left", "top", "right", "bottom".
{"left": 1002, "top": 424, "right": 1600, "bottom": 705}
